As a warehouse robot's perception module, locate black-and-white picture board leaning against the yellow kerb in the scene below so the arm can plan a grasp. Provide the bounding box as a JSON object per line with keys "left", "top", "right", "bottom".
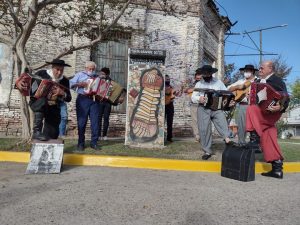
{"left": 26, "top": 143, "right": 64, "bottom": 174}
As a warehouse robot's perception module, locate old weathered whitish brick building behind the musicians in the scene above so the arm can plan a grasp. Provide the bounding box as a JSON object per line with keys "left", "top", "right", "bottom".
{"left": 0, "top": 0, "right": 231, "bottom": 137}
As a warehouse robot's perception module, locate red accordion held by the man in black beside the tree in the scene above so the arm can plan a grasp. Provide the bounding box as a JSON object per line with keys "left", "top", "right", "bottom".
{"left": 16, "top": 73, "right": 65, "bottom": 100}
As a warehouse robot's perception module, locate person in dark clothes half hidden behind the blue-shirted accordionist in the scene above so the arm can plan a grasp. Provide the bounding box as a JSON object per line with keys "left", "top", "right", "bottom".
{"left": 99, "top": 67, "right": 111, "bottom": 141}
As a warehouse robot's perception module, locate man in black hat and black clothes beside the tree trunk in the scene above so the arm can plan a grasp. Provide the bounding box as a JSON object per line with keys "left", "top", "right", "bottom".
{"left": 29, "top": 59, "right": 72, "bottom": 141}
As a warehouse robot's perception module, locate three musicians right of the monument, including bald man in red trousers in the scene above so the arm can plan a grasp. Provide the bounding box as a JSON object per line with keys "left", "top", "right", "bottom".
{"left": 191, "top": 61, "right": 289, "bottom": 178}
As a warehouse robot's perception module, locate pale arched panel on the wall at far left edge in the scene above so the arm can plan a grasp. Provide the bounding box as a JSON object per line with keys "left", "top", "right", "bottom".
{"left": 0, "top": 43, "right": 12, "bottom": 107}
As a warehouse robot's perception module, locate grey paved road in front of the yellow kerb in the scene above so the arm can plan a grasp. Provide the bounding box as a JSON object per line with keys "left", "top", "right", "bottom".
{"left": 0, "top": 163, "right": 300, "bottom": 225}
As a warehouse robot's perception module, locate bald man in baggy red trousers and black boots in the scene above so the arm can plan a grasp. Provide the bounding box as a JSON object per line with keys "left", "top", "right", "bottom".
{"left": 246, "top": 61, "right": 289, "bottom": 178}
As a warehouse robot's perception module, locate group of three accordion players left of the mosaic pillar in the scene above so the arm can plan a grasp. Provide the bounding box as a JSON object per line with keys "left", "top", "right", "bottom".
{"left": 16, "top": 59, "right": 125, "bottom": 152}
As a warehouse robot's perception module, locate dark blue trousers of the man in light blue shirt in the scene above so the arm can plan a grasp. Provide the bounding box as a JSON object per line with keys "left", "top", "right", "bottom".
{"left": 76, "top": 94, "right": 100, "bottom": 147}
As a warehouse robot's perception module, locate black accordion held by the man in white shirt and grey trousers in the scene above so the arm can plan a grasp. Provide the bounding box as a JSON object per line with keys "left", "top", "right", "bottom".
{"left": 203, "top": 89, "right": 234, "bottom": 111}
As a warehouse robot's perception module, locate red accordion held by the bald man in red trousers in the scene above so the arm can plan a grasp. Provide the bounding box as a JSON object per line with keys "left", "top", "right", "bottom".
{"left": 250, "top": 82, "right": 289, "bottom": 112}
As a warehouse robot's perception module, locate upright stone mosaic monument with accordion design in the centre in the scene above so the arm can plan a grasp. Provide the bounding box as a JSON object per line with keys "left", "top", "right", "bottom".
{"left": 125, "top": 49, "right": 166, "bottom": 148}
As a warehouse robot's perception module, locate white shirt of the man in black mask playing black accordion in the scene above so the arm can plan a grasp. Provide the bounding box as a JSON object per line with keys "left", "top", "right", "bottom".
{"left": 192, "top": 77, "right": 227, "bottom": 103}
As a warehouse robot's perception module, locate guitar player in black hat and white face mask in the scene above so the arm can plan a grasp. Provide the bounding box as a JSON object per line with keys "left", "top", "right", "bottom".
{"left": 228, "top": 64, "right": 258, "bottom": 145}
